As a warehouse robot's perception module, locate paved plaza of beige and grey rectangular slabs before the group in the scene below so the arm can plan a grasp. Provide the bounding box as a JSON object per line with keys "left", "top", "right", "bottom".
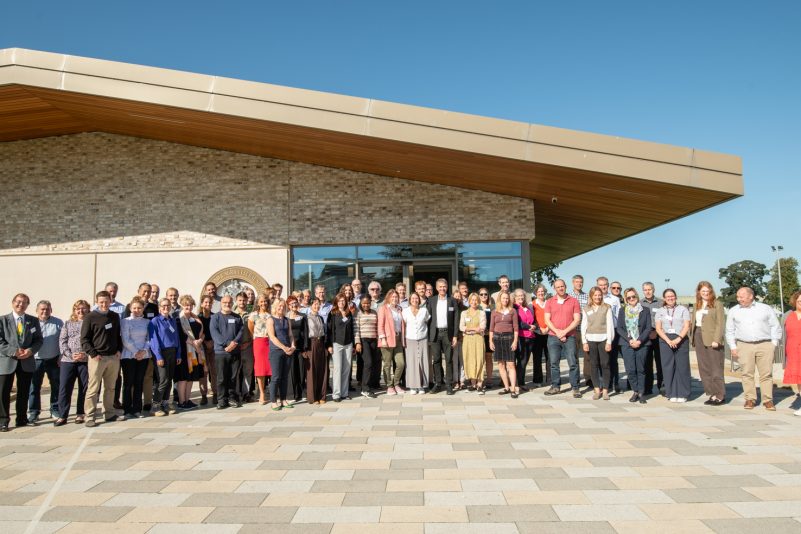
{"left": 0, "top": 381, "right": 801, "bottom": 534}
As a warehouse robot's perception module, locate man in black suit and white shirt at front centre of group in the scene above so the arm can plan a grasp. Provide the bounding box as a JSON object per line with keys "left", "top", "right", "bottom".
{"left": 425, "top": 278, "right": 459, "bottom": 395}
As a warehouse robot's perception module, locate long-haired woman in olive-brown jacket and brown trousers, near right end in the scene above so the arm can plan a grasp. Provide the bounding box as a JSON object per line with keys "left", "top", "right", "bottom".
{"left": 690, "top": 281, "right": 726, "bottom": 406}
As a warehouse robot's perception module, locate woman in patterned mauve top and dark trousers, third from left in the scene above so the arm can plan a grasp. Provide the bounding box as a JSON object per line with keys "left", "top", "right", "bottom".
{"left": 53, "top": 300, "right": 89, "bottom": 426}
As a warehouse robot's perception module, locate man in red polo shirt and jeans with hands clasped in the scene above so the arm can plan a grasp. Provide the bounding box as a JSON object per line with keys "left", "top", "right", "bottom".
{"left": 545, "top": 278, "right": 581, "bottom": 399}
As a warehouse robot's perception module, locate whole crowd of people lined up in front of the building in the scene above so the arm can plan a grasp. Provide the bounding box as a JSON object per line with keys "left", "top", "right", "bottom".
{"left": 0, "top": 275, "right": 801, "bottom": 432}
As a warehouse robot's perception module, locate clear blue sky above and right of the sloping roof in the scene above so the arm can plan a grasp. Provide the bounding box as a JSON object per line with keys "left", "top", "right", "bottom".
{"left": 0, "top": 0, "right": 801, "bottom": 294}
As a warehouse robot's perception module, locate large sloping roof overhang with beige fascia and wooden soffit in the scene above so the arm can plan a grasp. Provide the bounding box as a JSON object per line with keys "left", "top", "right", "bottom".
{"left": 0, "top": 48, "right": 743, "bottom": 269}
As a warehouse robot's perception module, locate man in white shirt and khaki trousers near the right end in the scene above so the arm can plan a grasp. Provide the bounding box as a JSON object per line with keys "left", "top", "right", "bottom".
{"left": 726, "top": 287, "right": 782, "bottom": 411}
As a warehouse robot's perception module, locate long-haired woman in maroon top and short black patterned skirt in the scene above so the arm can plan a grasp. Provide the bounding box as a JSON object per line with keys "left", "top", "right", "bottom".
{"left": 489, "top": 291, "right": 520, "bottom": 399}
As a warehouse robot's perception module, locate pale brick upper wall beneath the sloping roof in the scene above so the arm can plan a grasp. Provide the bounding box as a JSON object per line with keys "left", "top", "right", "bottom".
{"left": 0, "top": 133, "right": 534, "bottom": 254}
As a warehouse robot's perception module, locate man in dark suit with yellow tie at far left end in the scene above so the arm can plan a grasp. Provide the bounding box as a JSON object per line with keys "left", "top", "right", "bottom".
{"left": 0, "top": 293, "right": 42, "bottom": 432}
